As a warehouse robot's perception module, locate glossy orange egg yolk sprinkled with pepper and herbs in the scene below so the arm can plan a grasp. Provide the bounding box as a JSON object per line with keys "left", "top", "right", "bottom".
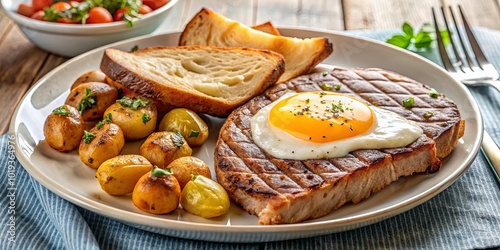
{"left": 268, "top": 91, "right": 375, "bottom": 143}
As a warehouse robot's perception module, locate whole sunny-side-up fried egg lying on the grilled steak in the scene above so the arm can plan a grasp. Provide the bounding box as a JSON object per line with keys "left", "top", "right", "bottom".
{"left": 250, "top": 91, "right": 423, "bottom": 160}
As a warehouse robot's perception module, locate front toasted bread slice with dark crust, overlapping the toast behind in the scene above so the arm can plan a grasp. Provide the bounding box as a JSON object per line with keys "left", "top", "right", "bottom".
{"left": 101, "top": 46, "right": 284, "bottom": 117}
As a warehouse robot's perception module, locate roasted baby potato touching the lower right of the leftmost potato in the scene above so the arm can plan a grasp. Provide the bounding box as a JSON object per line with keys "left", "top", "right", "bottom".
{"left": 78, "top": 122, "right": 125, "bottom": 168}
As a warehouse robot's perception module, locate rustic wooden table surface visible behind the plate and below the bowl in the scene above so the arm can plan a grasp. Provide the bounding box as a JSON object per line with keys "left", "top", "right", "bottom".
{"left": 0, "top": 0, "right": 500, "bottom": 135}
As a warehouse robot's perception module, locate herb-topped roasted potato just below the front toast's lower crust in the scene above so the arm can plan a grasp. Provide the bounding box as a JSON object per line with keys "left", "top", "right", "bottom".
{"left": 104, "top": 97, "right": 158, "bottom": 140}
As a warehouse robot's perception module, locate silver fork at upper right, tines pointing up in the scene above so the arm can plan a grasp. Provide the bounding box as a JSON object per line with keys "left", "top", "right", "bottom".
{"left": 432, "top": 5, "right": 500, "bottom": 91}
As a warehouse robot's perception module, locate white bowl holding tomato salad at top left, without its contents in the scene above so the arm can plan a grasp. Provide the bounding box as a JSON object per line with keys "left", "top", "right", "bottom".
{"left": 1, "top": 0, "right": 178, "bottom": 57}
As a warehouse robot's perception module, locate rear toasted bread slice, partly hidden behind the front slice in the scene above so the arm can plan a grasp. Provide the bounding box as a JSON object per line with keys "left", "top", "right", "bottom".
{"left": 179, "top": 8, "right": 333, "bottom": 82}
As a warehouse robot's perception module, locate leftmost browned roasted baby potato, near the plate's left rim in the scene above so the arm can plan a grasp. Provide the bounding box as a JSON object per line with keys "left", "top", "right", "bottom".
{"left": 43, "top": 105, "right": 85, "bottom": 151}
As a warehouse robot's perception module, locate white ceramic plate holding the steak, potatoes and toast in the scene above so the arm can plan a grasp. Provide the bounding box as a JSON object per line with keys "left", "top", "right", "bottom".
{"left": 10, "top": 28, "right": 482, "bottom": 242}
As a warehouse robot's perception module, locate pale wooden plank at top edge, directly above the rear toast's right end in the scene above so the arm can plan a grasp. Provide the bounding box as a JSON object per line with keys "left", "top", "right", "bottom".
{"left": 256, "top": 0, "right": 344, "bottom": 30}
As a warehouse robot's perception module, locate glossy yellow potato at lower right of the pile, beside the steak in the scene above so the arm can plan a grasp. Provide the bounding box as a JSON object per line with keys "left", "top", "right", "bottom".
{"left": 180, "top": 175, "right": 230, "bottom": 218}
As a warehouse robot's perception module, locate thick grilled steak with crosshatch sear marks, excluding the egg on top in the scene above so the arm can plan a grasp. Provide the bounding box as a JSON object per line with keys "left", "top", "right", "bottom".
{"left": 214, "top": 68, "right": 463, "bottom": 224}
